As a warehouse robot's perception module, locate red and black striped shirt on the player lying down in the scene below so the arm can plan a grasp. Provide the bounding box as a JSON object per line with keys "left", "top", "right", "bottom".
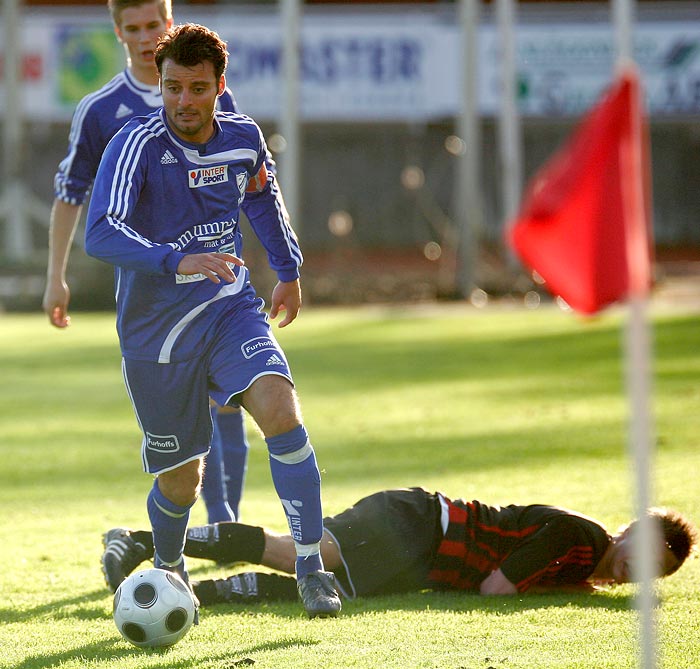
{"left": 429, "top": 497, "right": 611, "bottom": 592}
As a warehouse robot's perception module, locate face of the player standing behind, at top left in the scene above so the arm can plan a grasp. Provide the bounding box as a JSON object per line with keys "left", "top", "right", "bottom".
{"left": 114, "top": 2, "right": 173, "bottom": 83}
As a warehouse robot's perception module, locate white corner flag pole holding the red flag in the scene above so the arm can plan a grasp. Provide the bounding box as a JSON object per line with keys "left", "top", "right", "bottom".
{"left": 613, "top": 0, "right": 660, "bottom": 669}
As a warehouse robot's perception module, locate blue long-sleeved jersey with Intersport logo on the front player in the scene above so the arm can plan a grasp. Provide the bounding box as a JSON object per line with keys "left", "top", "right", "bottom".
{"left": 85, "top": 109, "right": 302, "bottom": 362}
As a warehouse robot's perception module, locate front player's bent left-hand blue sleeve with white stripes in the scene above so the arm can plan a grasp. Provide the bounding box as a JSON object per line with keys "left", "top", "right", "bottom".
{"left": 85, "top": 122, "right": 184, "bottom": 274}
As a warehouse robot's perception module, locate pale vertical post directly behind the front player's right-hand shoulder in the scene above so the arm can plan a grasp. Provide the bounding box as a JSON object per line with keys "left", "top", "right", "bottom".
{"left": 278, "top": 0, "right": 301, "bottom": 233}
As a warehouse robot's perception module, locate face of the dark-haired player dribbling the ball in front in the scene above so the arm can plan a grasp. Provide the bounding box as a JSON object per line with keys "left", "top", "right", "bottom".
{"left": 160, "top": 58, "right": 226, "bottom": 144}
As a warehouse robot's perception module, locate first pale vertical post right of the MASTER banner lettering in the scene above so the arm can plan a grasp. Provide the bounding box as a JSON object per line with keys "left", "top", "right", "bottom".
{"left": 455, "top": 0, "right": 483, "bottom": 297}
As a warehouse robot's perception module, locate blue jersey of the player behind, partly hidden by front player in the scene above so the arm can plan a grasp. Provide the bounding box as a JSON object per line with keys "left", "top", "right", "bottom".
{"left": 54, "top": 69, "right": 238, "bottom": 205}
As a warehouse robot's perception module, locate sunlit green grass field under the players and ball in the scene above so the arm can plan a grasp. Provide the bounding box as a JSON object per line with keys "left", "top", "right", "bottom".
{"left": 0, "top": 305, "right": 700, "bottom": 669}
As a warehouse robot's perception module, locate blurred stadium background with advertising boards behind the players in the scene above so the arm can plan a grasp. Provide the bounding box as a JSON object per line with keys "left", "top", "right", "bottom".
{"left": 0, "top": 0, "right": 700, "bottom": 311}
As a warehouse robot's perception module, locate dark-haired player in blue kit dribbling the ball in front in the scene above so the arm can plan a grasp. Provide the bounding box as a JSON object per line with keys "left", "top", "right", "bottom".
{"left": 86, "top": 24, "right": 341, "bottom": 617}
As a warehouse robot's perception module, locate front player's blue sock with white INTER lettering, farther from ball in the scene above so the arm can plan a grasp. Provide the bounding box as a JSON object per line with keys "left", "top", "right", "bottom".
{"left": 265, "top": 425, "right": 323, "bottom": 578}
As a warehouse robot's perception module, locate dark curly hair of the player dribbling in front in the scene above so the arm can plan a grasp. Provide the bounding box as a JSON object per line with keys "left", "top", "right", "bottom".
{"left": 155, "top": 23, "right": 228, "bottom": 81}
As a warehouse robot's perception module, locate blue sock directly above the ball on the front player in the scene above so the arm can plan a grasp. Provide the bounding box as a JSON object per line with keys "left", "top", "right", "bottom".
{"left": 146, "top": 479, "right": 192, "bottom": 581}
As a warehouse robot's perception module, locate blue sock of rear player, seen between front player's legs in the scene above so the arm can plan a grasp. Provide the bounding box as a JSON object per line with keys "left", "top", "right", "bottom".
{"left": 214, "top": 410, "right": 248, "bottom": 522}
